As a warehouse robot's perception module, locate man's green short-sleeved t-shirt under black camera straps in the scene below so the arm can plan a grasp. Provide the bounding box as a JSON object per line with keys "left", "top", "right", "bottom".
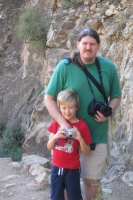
{"left": 45, "top": 56, "right": 121, "bottom": 143}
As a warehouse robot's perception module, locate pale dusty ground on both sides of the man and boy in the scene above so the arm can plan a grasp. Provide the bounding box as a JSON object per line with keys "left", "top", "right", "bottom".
{"left": 0, "top": 158, "right": 133, "bottom": 200}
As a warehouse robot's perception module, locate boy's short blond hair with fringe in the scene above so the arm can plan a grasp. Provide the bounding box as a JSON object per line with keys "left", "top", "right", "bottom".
{"left": 57, "top": 89, "right": 80, "bottom": 109}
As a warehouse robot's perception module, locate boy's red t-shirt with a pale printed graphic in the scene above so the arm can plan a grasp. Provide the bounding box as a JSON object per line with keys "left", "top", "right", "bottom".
{"left": 48, "top": 119, "right": 92, "bottom": 169}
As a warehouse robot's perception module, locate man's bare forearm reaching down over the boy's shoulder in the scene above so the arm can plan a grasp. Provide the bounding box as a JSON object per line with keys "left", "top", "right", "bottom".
{"left": 44, "top": 94, "right": 70, "bottom": 128}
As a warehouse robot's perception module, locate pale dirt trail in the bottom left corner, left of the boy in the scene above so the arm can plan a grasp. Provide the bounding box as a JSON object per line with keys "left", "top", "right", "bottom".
{"left": 0, "top": 158, "right": 50, "bottom": 200}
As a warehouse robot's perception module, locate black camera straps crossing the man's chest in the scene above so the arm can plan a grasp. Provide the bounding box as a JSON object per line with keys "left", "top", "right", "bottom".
{"left": 75, "top": 54, "right": 108, "bottom": 105}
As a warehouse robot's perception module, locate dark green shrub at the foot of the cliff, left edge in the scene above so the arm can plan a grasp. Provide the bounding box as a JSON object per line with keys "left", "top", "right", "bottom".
{"left": 0, "top": 124, "right": 24, "bottom": 161}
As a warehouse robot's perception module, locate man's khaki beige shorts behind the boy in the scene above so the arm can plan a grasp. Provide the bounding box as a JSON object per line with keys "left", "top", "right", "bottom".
{"left": 80, "top": 144, "right": 107, "bottom": 180}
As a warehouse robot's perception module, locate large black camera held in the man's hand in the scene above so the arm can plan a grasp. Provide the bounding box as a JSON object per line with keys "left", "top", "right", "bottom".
{"left": 88, "top": 99, "right": 112, "bottom": 117}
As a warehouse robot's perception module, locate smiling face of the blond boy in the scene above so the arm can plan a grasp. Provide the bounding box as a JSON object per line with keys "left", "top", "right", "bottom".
{"left": 60, "top": 103, "right": 77, "bottom": 122}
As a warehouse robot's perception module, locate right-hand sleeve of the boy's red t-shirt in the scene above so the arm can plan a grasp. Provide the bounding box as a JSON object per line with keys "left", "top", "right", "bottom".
{"left": 81, "top": 122, "right": 92, "bottom": 144}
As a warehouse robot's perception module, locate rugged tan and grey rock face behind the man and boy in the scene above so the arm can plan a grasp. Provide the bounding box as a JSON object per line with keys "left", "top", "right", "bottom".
{"left": 0, "top": 0, "right": 133, "bottom": 184}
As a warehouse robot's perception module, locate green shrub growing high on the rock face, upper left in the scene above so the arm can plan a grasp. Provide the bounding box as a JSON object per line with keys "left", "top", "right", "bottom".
{"left": 16, "top": 8, "right": 50, "bottom": 50}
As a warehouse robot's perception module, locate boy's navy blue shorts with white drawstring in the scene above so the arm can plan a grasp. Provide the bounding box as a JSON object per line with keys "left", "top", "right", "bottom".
{"left": 50, "top": 166, "right": 83, "bottom": 200}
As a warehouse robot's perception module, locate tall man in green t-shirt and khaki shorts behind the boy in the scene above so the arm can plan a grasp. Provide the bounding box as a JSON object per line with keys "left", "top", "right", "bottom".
{"left": 45, "top": 29, "right": 121, "bottom": 200}
